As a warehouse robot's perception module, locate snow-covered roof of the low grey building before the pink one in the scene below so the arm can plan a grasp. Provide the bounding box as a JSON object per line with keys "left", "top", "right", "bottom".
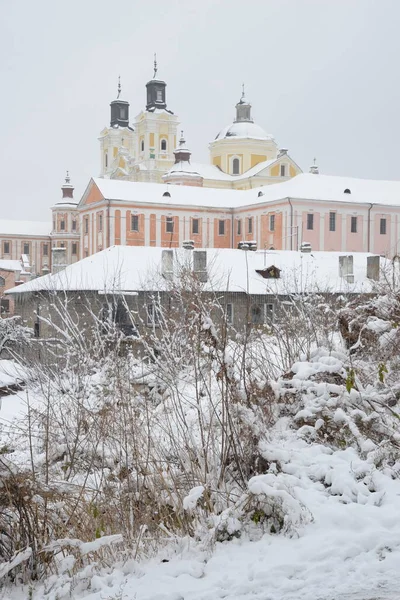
{"left": 6, "top": 246, "right": 391, "bottom": 295}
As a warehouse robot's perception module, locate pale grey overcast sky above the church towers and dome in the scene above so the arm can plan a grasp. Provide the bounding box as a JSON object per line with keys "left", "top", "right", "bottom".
{"left": 0, "top": 0, "right": 400, "bottom": 221}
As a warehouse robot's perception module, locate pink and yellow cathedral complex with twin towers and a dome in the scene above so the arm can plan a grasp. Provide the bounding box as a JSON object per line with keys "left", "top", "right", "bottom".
{"left": 0, "top": 63, "right": 400, "bottom": 310}
